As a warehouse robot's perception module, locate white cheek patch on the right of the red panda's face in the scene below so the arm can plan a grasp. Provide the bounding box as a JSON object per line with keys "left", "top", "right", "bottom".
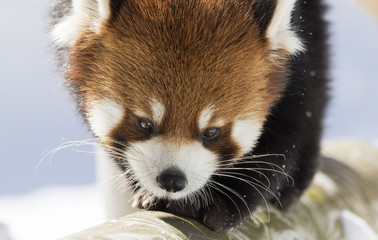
{"left": 232, "top": 119, "right": 262, "bottom": 154}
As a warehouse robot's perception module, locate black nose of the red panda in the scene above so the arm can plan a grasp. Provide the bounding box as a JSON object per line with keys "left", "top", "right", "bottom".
{"left": 156, "top": 168, "right": 188, "bottom": 193}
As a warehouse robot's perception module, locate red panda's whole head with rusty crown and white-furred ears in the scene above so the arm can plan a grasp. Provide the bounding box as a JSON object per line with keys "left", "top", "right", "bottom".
{"left": 53, "top": 0, "right": 302, "bottom": 204}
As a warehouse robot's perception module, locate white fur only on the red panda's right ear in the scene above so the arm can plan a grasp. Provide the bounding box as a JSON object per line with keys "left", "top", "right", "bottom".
{"left": 267, "top": 0, "right": 304, "bottom": 54}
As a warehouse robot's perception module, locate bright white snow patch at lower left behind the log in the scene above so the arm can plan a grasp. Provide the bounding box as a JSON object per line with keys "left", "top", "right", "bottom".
{"left": 0, "top": 185, "right": 106, "bottom": 240}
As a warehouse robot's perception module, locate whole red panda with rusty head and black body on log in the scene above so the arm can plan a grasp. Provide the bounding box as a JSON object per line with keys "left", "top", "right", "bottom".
{"left": 51, "top": 0, "right": 327, "bottom": 230}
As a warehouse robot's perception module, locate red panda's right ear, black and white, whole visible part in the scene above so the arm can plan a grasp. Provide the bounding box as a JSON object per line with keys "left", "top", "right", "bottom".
{"left": 253, "top": 0, "right": 304, "bottom": 54}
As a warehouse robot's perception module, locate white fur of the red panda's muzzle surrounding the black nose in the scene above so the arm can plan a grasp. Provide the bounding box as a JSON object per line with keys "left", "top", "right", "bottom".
{"left": 125, "top": 137, "right": 218, "bottom": 199}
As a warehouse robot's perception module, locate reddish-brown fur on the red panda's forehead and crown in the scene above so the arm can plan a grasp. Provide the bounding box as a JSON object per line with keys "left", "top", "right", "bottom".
{"left": 69, "top": 0, "right": 286, "bottom": 146}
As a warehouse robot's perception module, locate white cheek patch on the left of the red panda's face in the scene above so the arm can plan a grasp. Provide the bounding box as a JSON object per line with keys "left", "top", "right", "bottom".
{"left": 88, "top": 98, "right": 124, "bottom": 139}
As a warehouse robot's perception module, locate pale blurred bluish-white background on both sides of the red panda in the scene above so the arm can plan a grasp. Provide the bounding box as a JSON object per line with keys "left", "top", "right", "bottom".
{"left": 0, "top": 0, "right": 378, "bottom": 240}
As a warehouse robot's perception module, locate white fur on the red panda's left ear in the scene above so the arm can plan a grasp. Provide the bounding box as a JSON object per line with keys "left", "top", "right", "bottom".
{"left": 51, "top": 0, "right": 110, "bottom": 47}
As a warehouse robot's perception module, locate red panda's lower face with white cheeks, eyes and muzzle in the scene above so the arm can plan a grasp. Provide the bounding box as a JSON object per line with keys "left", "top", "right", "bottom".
{"left": 88, "top": 96, "right": 262, "bottom": 199}
